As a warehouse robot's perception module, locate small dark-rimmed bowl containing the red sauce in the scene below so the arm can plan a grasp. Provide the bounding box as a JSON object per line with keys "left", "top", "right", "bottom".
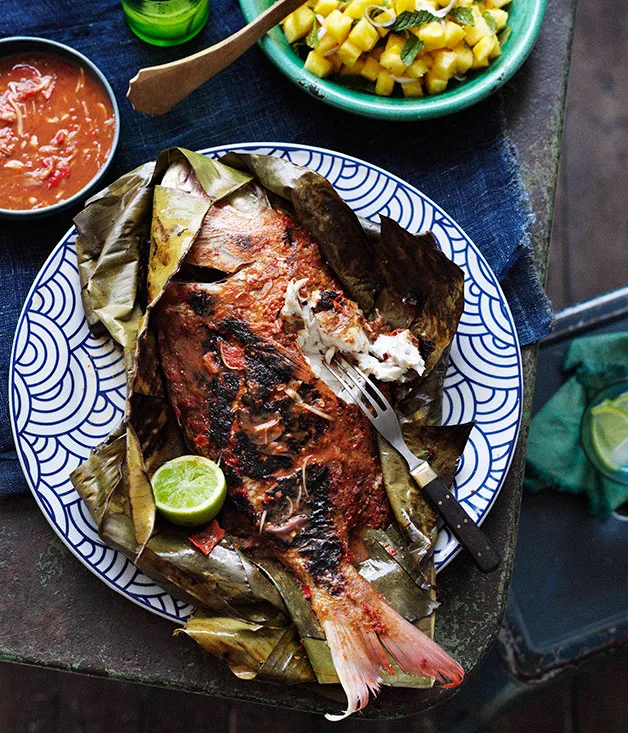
{"left": 0, "top": 36, "right": 120, "bottom": 220}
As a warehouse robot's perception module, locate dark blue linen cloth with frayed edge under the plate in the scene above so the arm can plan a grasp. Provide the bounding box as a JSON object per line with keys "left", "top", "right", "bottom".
{"left": 0, "top": 0, "right": 552, "bottom": 496}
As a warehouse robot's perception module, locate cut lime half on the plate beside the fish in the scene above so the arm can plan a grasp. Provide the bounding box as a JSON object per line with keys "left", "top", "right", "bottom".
{"left": 152, "top": 456, "right": 227, "bottom": 527}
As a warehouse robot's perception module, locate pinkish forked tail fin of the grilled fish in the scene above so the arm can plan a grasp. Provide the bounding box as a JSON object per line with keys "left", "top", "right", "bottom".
{"left": 313, "top": 568, "right": 464, "bottom": 721}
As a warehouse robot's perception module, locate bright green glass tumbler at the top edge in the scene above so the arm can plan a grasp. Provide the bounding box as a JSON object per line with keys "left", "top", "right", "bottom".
{"left": 122, "top": 0, "right": 209, "bottom": 46}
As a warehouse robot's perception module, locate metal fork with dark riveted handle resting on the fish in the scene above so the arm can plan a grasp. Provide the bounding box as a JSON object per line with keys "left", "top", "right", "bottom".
{"left": 323, "top": 354, "right": 500, "bottom": 573}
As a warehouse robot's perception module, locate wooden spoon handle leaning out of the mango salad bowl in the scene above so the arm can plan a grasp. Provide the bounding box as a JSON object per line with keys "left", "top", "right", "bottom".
{"left": 126, "top": 0, "right": 304, "bottom": 115}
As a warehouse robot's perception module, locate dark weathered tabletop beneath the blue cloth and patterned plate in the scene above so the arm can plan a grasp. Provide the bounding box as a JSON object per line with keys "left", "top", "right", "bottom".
{"left": 0, "top": 0, "right": 576, "bottom": 718}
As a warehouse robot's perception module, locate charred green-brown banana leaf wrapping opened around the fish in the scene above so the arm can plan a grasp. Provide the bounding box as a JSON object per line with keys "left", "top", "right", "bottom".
{"left": 72, "top": 148, "right": 471, "bottom": 687}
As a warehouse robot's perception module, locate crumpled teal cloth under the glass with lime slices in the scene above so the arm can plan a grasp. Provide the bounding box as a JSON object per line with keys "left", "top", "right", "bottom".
{"left": 525, "top": 333, "right": 628, "bottom": 518}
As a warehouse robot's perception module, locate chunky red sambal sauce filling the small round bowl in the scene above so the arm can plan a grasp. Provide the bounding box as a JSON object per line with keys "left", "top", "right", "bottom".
{"left": 0, "top": 54, "right": 116, "bottom": 210}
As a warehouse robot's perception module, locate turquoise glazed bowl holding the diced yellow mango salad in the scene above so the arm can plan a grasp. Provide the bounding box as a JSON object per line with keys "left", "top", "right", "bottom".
{"left": 239, "top": 0, "right": 547, "bottom": 120}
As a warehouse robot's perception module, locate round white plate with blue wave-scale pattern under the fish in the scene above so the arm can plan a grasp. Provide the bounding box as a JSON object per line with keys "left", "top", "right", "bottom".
{"left": 9, "top": 143, "right": 523, "bottom": 623}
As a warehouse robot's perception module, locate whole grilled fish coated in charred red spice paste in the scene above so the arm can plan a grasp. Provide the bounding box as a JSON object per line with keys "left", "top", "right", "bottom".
{"left": 153, "top": 164, "right": 464, "bottom": 715}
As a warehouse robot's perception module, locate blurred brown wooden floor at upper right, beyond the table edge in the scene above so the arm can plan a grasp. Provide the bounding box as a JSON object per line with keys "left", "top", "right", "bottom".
{"left": 547, "top": 0, "right": 628, "bottom": 309}
